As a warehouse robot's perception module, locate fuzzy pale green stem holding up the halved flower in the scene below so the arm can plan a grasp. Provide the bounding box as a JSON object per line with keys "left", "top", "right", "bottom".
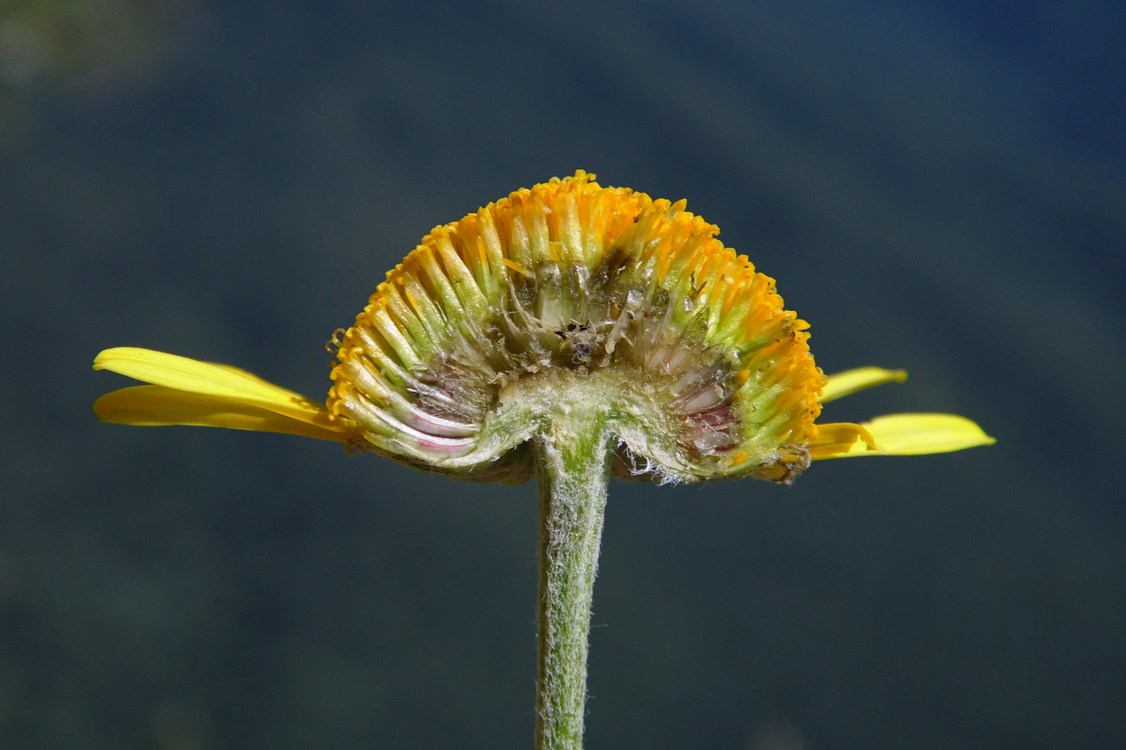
{"left": 535, "top": 409, "right": 609, "bottom": 750}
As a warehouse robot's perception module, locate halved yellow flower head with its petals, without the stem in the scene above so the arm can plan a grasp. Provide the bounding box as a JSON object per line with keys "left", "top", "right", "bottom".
{"left": 95, "top": 171, "right": 993, "bottom": 481}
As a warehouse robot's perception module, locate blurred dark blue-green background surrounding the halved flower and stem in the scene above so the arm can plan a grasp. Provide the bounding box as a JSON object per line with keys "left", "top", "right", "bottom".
{"left": 0, "top": 0, "right": 1126, "bottom": 750}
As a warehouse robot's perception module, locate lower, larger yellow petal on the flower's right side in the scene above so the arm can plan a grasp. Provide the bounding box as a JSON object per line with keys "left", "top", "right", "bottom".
{"left": 810, "top": 414, "right": 997, "bottom": 458}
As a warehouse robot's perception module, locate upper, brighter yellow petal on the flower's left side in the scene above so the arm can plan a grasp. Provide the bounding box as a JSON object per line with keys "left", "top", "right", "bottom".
{"left": 93, "top": 347, "right": 327, "bottom": 425}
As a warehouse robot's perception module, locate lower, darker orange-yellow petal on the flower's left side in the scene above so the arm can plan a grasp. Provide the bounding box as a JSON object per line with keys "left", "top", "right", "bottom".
{"left": 93, "top": 385, "right": 349, "bottom": 441}
